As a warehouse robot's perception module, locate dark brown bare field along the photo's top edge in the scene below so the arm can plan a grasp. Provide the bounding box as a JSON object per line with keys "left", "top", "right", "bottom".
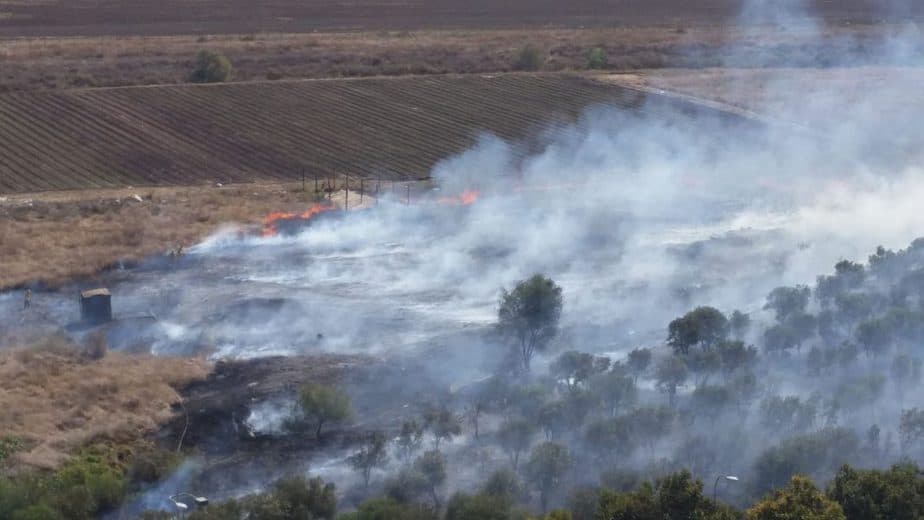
{"left": 0, "top": 0, "right": 924, "bottom": 37}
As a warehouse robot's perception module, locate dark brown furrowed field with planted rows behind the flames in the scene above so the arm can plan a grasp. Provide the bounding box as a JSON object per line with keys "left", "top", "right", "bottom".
{"left": 0, "top": 75, "right": 656, "bottom": 194}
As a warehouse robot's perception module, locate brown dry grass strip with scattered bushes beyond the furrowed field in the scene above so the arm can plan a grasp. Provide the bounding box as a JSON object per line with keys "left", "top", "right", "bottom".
{"left": 0, "top": 21, "right": 888, "bottom": 91}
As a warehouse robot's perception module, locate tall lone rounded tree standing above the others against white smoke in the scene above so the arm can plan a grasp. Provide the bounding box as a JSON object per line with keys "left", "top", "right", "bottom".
{"left": 497, "top": 274, "right": 563, "bottom": 372}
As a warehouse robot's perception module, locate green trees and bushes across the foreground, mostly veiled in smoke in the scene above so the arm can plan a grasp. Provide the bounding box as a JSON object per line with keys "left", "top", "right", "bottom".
{"left": 14, "top": 240, "right": 924, "bottom": 520}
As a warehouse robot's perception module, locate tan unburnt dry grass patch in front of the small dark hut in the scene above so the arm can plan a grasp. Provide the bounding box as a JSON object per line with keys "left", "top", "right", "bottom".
{"left": 0, "top": 337, "right": 210, "bottom": 469}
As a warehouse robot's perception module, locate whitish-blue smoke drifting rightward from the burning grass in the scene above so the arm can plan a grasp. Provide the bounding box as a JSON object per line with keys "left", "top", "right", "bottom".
{"left": 18, "top": 0, "right": 924, "bottom": 512}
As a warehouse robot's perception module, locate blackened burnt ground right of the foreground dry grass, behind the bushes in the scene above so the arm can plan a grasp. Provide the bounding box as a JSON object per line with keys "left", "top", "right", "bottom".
{"left": 158, "top": 331, "right": 497, "bottom": 464}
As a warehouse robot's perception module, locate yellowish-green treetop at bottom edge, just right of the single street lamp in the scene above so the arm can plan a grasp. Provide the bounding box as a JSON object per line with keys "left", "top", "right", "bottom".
{"left": 745, "top": 475, "right": 846, "bottom": 520}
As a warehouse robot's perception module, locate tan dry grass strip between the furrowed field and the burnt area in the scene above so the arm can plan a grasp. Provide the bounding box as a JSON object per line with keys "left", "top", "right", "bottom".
{"left": 0, "top": 184, "right": 370, "bottom": 290}
